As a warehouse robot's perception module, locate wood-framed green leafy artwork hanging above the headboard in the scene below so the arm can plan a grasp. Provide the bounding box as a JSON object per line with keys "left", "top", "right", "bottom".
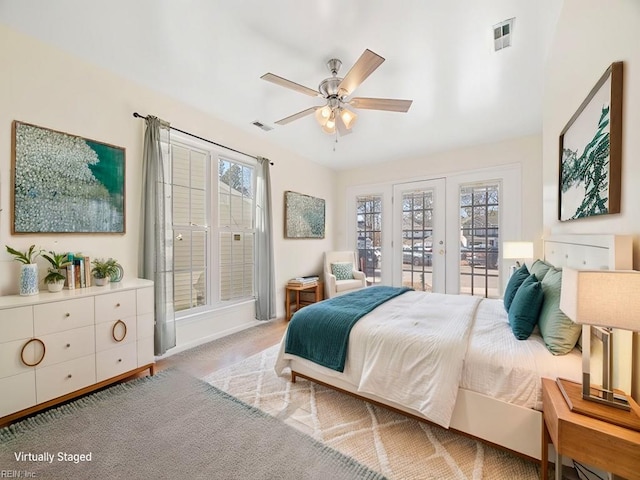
{"left": 558, "top": 62, "right": 622, "bottom": 221}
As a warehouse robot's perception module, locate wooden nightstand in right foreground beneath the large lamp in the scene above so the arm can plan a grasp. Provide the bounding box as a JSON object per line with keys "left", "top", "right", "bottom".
{"left": 542, "top": 378, "right": 640, "bottom": 480}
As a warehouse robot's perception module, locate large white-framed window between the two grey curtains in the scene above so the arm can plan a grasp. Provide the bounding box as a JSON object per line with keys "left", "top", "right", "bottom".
{"left": 169, "top": 133, "right": 255, "bottom": 316}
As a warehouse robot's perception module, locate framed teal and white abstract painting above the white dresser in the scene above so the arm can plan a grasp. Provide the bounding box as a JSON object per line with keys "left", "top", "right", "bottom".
{"left": 11, "top": 121, "right": 125, "bottom": 234}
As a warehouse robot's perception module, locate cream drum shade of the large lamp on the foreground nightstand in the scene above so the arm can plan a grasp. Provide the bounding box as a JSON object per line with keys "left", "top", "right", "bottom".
{"left": 560, "top": 267, "right": 640, "bottom": 331}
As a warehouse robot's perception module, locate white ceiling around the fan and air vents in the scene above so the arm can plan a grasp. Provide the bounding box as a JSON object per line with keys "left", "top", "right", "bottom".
{"left": 0, "top": 0, "right": 562, "bottom": 169}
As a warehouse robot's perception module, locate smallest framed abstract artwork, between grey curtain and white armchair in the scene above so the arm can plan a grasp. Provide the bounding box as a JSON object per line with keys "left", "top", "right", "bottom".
{"left": 284, "top": 191, "right": 325, "bottom": 238}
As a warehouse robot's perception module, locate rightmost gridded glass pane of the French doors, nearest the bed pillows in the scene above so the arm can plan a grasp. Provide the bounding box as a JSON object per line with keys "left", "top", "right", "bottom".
{"left": 460, "top": 182, "right": 500, "bottom": 298}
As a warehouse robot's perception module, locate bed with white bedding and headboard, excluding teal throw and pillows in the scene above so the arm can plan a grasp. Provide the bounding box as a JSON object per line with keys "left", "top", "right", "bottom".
{"left": 275, "top": 235, "right": 632, "bottom": 460}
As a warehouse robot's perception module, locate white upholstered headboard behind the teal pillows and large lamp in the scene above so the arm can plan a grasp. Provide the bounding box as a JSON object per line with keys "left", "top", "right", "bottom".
{"left": 544, "top": 234, "right": 640, "bottom": 401}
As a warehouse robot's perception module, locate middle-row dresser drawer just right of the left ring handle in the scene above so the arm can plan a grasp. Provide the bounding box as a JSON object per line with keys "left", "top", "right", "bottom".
{"left": 38, "top": 326, "right": 96, "bottom": 368}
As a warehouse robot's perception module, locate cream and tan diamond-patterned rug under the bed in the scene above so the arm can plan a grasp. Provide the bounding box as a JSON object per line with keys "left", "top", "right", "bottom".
{"left": 204, "top": 346, "right": 539, "bottom": 480}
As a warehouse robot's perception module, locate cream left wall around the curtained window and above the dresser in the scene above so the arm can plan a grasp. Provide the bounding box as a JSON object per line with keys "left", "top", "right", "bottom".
{"left": 0, "top": 25, "right": 335, "bottom": 343}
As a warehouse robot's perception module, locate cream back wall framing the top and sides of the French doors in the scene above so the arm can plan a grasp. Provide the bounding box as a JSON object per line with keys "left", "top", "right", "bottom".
{"left": 333, "top": 135, "right": 542, "bottom": 253}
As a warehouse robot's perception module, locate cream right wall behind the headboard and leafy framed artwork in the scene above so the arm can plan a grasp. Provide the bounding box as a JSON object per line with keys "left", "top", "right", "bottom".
{"left": 542, "top": 0, "right": 640, "bottom": 400}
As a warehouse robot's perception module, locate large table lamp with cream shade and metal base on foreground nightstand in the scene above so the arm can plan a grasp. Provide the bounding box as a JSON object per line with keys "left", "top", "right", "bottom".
{"left": 558, "top": 267, "right": 640, "bottom": 410}
